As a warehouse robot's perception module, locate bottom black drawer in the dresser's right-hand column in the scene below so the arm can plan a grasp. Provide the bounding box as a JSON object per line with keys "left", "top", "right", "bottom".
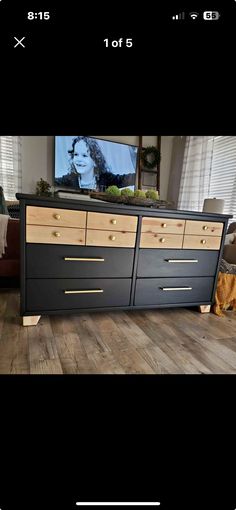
{"left": 135, "top": 277, "right": 214, "bottom": 306}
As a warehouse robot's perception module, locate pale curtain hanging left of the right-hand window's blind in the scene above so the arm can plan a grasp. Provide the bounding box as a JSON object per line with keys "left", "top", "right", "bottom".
{"left": 178, "top": 136, "right": 214, "bottom": 211}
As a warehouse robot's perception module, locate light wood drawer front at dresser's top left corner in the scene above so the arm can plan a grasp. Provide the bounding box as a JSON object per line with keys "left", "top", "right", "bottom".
{"left": 26, "top": 205, "right": 87, "bottom": 228}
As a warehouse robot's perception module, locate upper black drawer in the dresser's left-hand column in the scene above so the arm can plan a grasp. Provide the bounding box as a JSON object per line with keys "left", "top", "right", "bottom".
{"left": 26, "top": 244, "right": 134, "bottom": 278}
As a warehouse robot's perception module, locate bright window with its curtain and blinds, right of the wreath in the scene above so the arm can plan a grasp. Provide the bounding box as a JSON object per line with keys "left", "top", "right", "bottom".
{"left": 178, "top": 136, "right": 236, "bottom": 221}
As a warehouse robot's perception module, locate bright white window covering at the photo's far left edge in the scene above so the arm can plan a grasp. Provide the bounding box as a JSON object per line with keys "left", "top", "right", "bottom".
{"left": 0, "top": 136, "right": 22, "bottom": 200}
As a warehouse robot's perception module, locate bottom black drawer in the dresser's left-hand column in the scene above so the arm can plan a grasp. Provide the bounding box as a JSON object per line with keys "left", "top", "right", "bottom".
{"left": 26, "top": 278, "right": 131, "bottom": 312}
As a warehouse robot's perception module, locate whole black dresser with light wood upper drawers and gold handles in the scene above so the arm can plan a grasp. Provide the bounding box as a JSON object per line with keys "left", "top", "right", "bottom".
{"left": 17, "top": 194, "right": 232, "bottom": 326}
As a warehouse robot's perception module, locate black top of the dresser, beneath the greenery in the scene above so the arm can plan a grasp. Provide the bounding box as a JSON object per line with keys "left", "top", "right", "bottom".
{"left": 16, "top": 193, "right": 233, "bottom": 221}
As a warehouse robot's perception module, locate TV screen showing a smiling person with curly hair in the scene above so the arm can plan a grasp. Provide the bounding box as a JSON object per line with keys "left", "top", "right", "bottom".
{"left": 54, "top": 136, "right": 138, "bottom": 191}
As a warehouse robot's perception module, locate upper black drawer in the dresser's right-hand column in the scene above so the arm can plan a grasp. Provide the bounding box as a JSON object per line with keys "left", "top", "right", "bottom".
{"left": 138, "top": 249, "right": 219, "bottom": 278}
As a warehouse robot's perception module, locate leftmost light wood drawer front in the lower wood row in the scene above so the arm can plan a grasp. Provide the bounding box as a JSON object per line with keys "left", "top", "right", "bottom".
{"left": 26, "top": 225, "right": 85, "bottom": 245}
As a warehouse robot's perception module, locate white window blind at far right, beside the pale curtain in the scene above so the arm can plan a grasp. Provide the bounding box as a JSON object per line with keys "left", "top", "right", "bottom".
{"left": 209, "top": 136, "right": 236, "bottom": 222}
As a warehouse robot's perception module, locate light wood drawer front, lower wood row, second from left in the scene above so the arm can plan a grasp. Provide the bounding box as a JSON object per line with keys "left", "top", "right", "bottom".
{"left": 86, "top": 229, "right": 136, "bottom": 248}
